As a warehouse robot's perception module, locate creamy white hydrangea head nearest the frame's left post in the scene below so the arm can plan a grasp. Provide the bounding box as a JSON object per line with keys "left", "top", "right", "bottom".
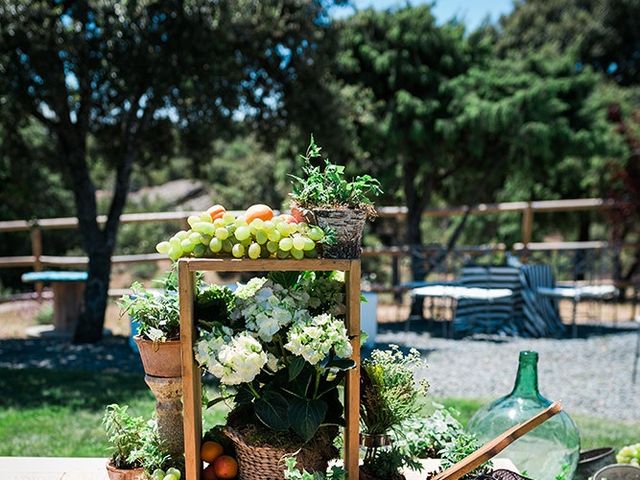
{"left": 196, "top": 327, "right": 264, "bottom": 385}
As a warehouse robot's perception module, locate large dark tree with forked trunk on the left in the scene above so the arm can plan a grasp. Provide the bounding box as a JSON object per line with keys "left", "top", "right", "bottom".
{"left": 0, "top": 0, "right": 338, "bottom": 342}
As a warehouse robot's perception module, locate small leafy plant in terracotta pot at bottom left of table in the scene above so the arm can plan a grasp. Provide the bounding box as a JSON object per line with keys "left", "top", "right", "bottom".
{"left": 102, "top": 404, "right": 146, "bottom": 480}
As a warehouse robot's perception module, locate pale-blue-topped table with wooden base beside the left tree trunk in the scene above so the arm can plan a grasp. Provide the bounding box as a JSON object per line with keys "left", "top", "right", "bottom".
{"left": 22, "top": 271, "right": 88, "bottom": 334}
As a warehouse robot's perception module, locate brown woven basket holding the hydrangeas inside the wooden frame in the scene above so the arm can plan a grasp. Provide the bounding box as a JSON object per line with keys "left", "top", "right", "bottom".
{"left": 224, "top": 427, "right": 329, "bottom": 480}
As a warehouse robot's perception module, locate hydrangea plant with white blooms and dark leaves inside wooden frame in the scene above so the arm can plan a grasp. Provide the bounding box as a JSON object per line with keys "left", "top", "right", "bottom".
{"left": 196, "top": 274, "right": 354, "bottom": 443}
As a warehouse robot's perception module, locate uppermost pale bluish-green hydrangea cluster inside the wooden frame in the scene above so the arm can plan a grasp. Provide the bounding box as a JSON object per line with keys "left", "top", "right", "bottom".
{"left": 231, "top": 278, "right": 309, "bottom": 342}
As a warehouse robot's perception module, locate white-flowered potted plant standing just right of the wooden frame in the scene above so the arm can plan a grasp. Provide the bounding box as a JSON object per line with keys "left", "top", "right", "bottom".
{"left": 360, "top": 345, "right": 429, "bottom": 480}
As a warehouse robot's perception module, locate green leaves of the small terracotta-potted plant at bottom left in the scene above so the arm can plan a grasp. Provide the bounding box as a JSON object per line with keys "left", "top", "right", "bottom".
{"left": 102, "top": 404, "right": 146, "bottom": 469}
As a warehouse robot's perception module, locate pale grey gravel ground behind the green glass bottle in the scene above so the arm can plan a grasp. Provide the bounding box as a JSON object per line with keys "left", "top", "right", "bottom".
{"left": 376, "top": 326, "right": 640, "bottom": 421}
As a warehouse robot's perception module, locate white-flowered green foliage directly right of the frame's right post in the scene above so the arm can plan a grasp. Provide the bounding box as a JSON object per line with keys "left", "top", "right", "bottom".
{"left": 360, "top": 345, "right": 429, "bottom": 435}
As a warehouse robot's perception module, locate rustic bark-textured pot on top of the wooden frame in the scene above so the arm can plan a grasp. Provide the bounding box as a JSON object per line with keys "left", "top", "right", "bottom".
{"left": 312, "top": 209, "right": 367, "bottom": 258}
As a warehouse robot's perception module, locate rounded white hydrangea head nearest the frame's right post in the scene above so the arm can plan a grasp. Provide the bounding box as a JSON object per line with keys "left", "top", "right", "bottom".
{"left": 284, "top": 314, "right": 352, "bottom": 365}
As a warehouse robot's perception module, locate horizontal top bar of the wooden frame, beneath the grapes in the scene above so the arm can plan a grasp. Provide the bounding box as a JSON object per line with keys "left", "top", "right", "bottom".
{"left": 186, "top": 258, "right": 352, "bottom": 272}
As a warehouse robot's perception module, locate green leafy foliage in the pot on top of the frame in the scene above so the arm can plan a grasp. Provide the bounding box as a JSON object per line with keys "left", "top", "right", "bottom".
{"left": 289, "top": 135, "right": 382, "bottom": 215}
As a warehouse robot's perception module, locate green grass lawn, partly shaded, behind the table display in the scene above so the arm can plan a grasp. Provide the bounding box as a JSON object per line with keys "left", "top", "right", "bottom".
{"left": 0, "top": 369, "right": 640, "bottom": 457}
